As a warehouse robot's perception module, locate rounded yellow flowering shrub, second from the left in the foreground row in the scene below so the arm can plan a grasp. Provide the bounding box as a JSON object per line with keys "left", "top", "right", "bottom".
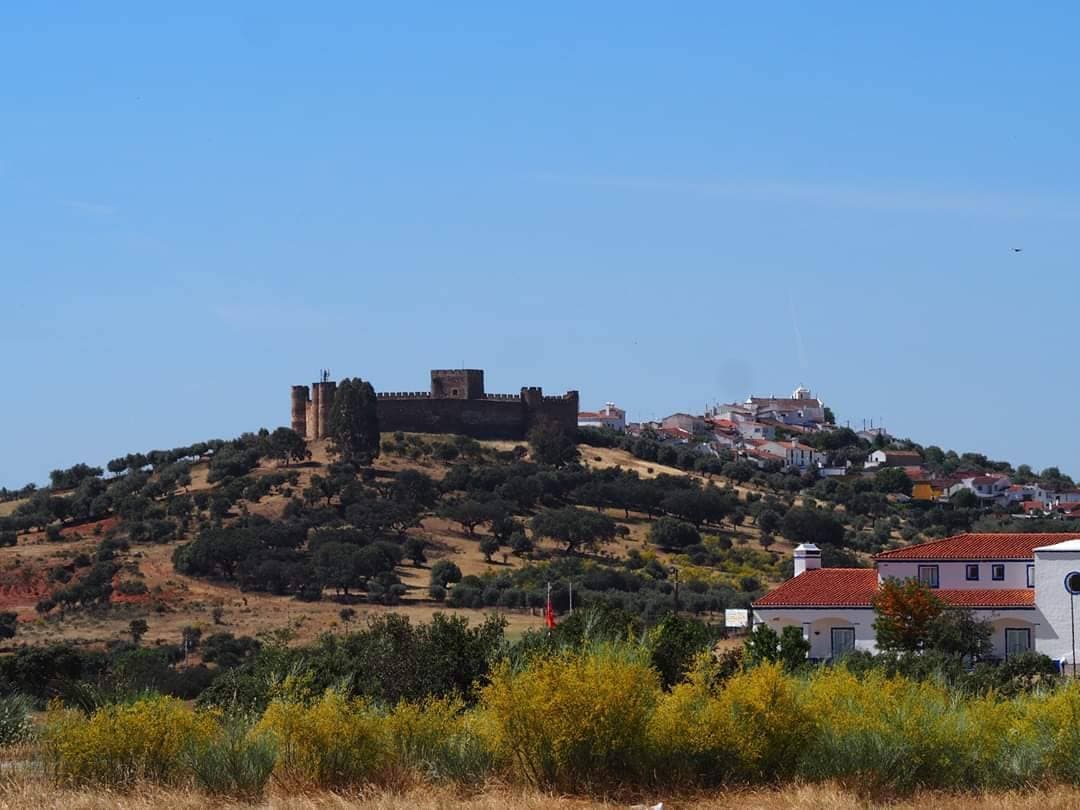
{"left": 254, "top": 690, "right": 388, "bottom": 787}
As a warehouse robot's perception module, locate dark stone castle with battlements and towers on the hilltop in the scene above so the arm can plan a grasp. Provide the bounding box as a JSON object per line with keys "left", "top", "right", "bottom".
{"left": 292, "top": 368, "right": 578, "bottom": 438}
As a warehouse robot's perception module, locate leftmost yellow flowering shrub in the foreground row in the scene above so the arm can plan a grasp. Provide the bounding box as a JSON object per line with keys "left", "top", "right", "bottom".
{"left": 43, "top": 697, "right": 217, "bottom": 786}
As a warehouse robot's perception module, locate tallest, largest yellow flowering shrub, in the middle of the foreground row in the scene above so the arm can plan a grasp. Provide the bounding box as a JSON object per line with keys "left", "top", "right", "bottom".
{"left": 481, "top": 645, "right": 660, "bottom": 789}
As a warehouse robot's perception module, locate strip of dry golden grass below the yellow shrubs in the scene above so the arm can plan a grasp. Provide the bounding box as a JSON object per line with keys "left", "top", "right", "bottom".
{"left": 0, "top": 779, "right": 1080, "bottom": 810}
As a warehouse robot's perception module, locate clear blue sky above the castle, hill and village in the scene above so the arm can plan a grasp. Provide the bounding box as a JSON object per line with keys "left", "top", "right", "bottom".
{"left": 0, "top": 2, "right": 1080, "bottom": 486}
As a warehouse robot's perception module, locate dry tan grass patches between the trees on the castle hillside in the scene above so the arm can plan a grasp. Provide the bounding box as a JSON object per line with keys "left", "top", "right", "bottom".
{"left": 0, "top": 436, "right": 791, "bottom": 645}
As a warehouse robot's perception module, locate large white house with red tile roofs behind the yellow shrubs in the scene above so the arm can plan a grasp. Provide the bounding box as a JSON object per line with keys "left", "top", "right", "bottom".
{"left": 753, "top": 534, "right": 1080, "bottom": 665}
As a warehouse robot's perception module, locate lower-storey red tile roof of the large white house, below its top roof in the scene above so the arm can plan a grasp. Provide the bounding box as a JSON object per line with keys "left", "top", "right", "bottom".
{"left": 754, "top": 568, "right": 1035, "bottom": 608}
